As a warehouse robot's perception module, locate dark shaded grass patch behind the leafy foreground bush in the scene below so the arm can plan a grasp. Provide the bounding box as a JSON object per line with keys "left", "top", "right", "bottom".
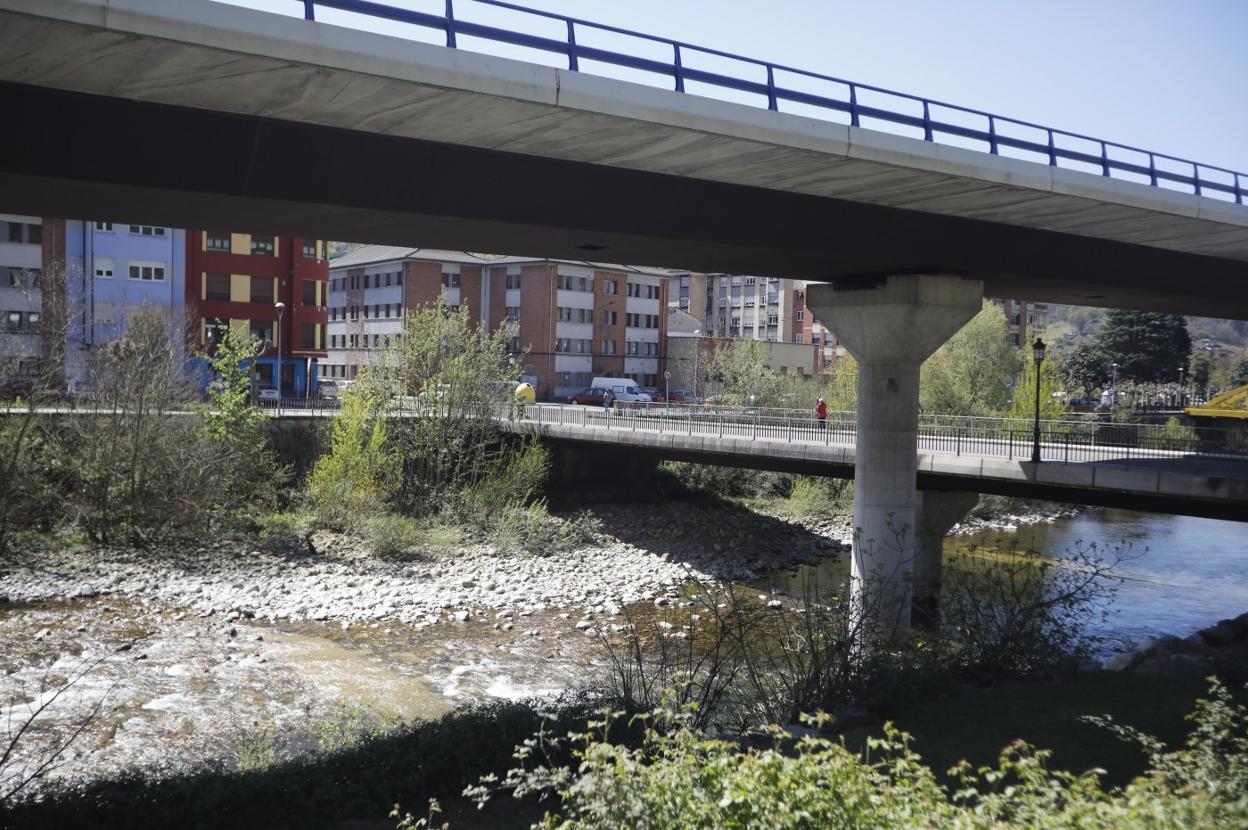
{"left": 847, "top": 671, "right": 1208, "bottom": 785}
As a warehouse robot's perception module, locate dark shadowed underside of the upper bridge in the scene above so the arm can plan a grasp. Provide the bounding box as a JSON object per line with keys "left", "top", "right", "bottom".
{"left": 0, "top": 84, "right": 1248, "bottom": 318}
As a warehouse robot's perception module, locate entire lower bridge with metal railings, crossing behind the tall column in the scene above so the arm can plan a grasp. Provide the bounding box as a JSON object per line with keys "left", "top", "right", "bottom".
{"left": 502, "top": 404, "right": 1248, "bottom": 520}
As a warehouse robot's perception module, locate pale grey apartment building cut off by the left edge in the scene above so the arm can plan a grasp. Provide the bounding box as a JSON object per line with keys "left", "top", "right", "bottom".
{"left": 0, "top": 213, "right": 45, "bottom": 386}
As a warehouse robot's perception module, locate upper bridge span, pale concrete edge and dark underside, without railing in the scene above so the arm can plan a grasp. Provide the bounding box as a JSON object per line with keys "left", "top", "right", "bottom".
{"left": 0, "top": 0, "right": 1248, "bottom": 318}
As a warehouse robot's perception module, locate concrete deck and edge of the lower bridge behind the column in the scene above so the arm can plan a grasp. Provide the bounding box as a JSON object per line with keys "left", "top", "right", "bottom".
{"left": 502, "top": 406, "right": 1248, "bottom": 522}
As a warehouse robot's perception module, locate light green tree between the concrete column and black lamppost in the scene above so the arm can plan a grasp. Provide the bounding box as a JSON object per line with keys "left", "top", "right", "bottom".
{"left": 919, "top": 302, "right": 1022, "bottom": 416}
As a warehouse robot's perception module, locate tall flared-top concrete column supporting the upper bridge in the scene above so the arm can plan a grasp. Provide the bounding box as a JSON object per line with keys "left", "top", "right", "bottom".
{"left": 806, "top": 275, "right": 983, "bottom": 639}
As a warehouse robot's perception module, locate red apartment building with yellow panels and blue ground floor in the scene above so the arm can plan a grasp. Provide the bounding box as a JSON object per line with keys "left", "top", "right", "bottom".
{"left": 186, "top": 230, "right": 329, "bottom": 397}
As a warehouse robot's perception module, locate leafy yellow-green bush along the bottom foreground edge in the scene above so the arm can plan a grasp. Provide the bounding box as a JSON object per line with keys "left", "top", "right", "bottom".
{"left": 466, "top": 683, "right": 1248, "bottom": 830}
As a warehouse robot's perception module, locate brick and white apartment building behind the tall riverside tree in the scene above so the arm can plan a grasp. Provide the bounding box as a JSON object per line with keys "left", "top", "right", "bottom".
{"left": 322, "top": 245, "right": 669, "bottom": 399}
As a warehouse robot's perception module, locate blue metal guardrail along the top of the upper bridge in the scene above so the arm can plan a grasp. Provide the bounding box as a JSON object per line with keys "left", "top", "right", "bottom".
{"left": 275, "top": 0, "right": 1248, "bottom": 205}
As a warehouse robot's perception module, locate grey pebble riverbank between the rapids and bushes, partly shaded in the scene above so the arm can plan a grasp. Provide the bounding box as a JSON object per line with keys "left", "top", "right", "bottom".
{"left": 0, "top": 504, "right": 844, "bottom": 627}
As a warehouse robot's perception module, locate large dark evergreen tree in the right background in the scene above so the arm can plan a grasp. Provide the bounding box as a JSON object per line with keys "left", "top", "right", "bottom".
{"left": 1096, "top": 310, "right": 1192, "bottom": 383}
